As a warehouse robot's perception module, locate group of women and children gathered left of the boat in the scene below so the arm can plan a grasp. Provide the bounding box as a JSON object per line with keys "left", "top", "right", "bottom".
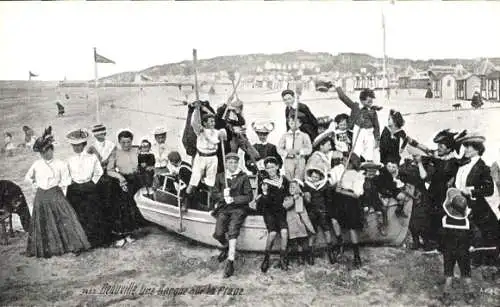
{"left": 25, "top": 125, "right": 189, "bottom": 257}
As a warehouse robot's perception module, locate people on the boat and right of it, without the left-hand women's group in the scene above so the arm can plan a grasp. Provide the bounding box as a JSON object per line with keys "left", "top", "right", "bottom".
{"left": 176, "top": 88, "right": 500, "bottom": 304}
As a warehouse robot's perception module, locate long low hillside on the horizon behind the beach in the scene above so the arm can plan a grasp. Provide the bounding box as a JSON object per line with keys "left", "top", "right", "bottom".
{"left": 96, "top": 50, "right": 497, "bottom": 82}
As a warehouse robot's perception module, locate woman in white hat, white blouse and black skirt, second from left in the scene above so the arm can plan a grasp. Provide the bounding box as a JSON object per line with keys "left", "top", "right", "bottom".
{"left": 66, "top": 129, "right": 111, "bottom": 247}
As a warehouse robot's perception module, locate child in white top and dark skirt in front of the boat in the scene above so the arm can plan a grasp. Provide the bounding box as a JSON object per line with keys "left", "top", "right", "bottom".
{"left": 335, "top": 154, "right": 365, "bottom": 268}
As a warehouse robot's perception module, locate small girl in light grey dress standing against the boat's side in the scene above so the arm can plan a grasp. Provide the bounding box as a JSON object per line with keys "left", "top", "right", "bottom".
{"left": 283, "top": 179, "right": 316, "bottom": 265}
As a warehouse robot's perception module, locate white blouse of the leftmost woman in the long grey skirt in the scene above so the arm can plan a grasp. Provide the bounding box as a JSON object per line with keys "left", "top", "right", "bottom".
{"left": 25, "top": 159, "right": 71, "bottom": 190}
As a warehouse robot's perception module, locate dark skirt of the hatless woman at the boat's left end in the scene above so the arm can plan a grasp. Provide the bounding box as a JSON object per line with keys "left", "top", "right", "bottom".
{"left": 110, "top": 174, "right": 148, "bottom": 238}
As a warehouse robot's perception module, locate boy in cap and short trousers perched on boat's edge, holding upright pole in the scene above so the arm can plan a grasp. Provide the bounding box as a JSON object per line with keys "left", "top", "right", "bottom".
{"left": 213, "top": 153, "right": 253, "bottom": 278}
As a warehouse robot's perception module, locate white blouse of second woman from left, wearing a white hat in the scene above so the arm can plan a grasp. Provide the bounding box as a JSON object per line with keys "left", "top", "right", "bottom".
{"left": 68, "top": 151, "right": 104, "bottom": 184}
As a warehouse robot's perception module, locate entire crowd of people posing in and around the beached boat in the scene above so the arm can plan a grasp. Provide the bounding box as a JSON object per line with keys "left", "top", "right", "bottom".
{"left": 10, "top": 87, "right": 500, "bottom": 304}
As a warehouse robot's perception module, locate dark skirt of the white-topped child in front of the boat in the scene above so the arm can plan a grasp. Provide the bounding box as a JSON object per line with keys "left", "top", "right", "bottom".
{"left": 335, "top": 193, "right": 364, "bottom": 230}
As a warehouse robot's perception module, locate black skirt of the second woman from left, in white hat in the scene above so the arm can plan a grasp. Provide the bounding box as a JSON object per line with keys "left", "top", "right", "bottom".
{"left": 66, "top": 181, "right": 112, "bottom": 247}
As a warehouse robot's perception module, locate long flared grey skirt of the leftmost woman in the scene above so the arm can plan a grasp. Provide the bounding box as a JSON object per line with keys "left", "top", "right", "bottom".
{"left": 26, "top": 187, "right": 91, "bottom": 258}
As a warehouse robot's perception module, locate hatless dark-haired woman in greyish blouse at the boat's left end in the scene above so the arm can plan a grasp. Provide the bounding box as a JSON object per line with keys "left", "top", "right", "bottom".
{"left": 107, "top": 130, "right": 144, "bottom": 247}
